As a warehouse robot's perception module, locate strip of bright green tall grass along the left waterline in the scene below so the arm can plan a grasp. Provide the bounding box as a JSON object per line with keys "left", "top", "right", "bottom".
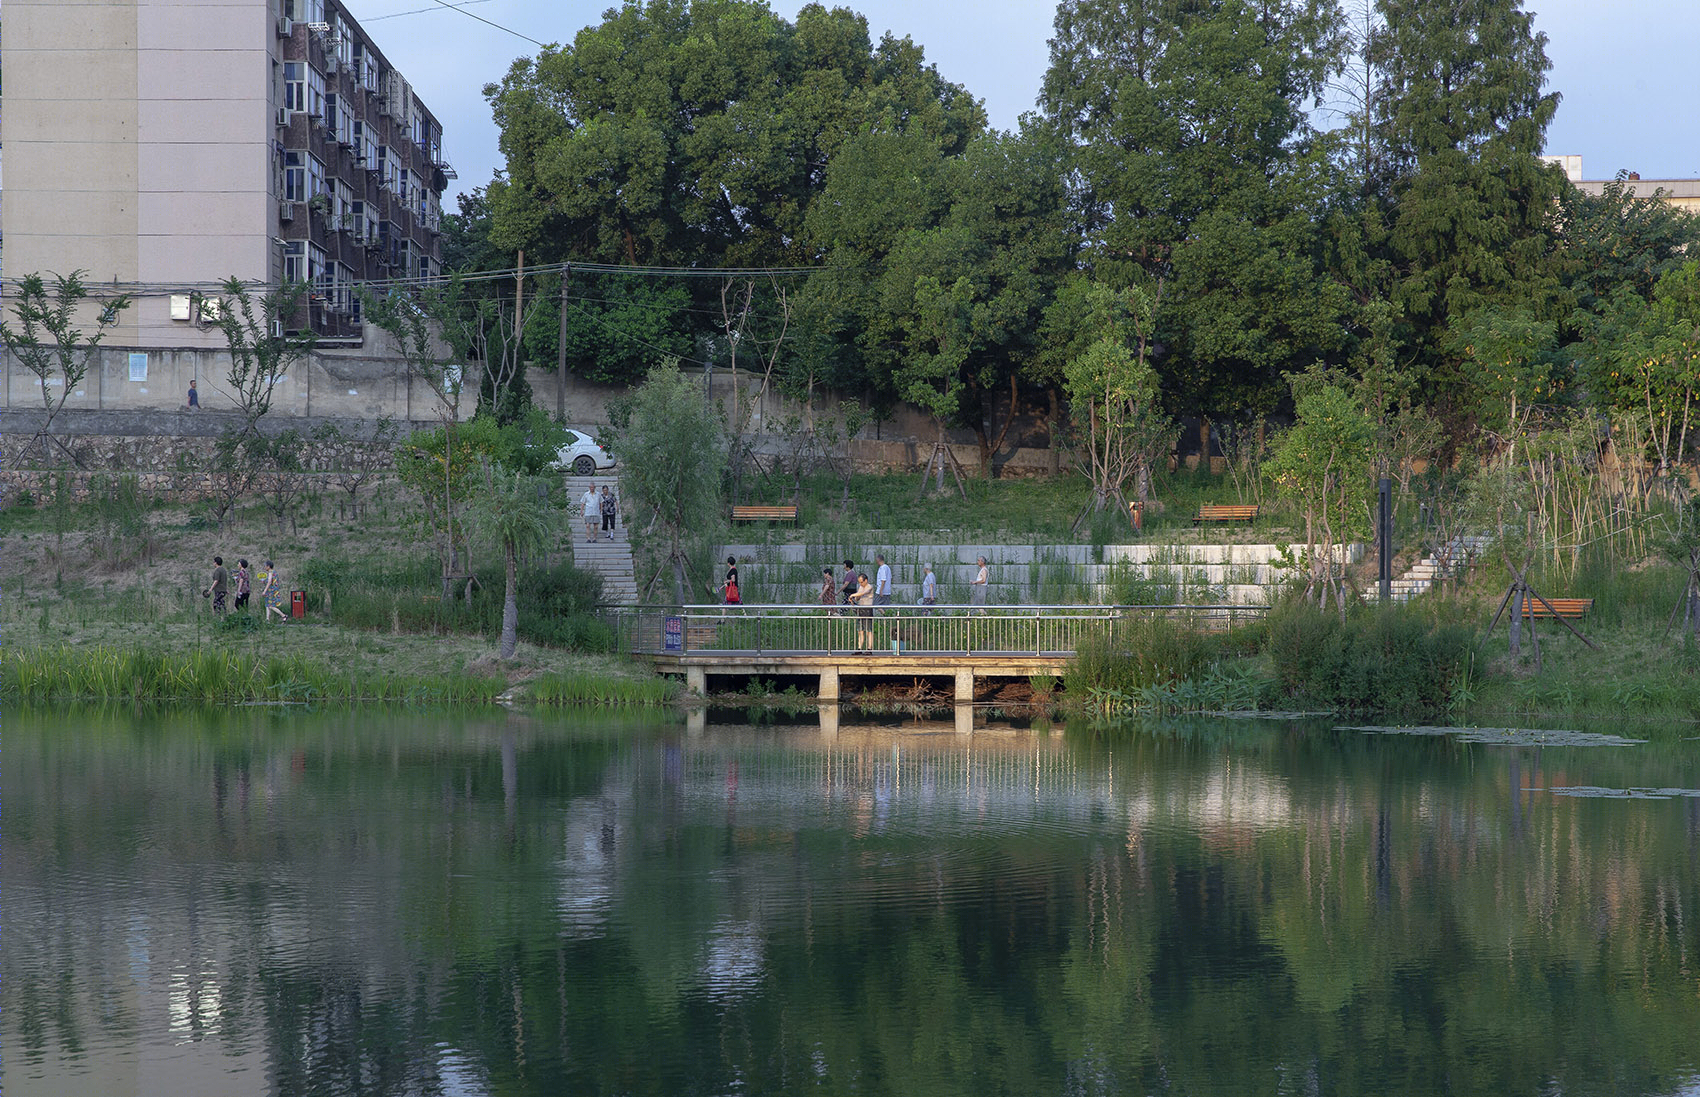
{"left": 0, "top": 645, "right": 507, "bottom": 704}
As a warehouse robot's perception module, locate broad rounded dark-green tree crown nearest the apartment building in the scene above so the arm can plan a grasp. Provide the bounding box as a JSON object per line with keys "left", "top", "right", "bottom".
{"left": 485, "top": 0, "right": 984, "bottom": 267}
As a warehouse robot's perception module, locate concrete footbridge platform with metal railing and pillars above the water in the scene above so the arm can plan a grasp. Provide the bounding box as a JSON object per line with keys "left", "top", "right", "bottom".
{"left": 604, "top": 605, "right": 1265, "bottom": 701}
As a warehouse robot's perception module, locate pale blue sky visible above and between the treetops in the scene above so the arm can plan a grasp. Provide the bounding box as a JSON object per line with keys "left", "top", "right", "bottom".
{"left": 349, "top": 0, "right": 1700, "bottom": 204}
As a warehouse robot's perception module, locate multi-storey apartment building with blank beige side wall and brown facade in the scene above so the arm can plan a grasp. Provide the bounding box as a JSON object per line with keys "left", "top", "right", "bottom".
{"left": 0, "top": 0, "right": 454, "bottom": 349}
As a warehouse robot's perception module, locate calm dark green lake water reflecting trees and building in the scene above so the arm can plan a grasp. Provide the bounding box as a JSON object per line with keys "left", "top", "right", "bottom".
{"left": 0, "top": 709, "right": 1700, "bottom": 1097}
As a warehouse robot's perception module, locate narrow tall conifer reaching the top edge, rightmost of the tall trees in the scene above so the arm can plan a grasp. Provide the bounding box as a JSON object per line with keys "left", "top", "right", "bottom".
{"left": 1370, "top": 0, "right": 1567, "bottom": 425}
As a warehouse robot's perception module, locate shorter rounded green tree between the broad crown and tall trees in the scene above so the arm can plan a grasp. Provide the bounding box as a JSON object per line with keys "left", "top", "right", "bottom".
{"left": 808, "top": 129, "right": 1073, "bottom": 475}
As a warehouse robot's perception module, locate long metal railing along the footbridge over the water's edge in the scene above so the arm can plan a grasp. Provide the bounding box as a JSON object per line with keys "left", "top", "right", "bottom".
{"left": 598, "top": 605, "right": 1267, "bottom": 655}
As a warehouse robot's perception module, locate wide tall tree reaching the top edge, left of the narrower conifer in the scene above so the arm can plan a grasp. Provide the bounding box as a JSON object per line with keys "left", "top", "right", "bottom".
{"left": 1040, "top": 0, "right": 1348, "bottom": 423}
